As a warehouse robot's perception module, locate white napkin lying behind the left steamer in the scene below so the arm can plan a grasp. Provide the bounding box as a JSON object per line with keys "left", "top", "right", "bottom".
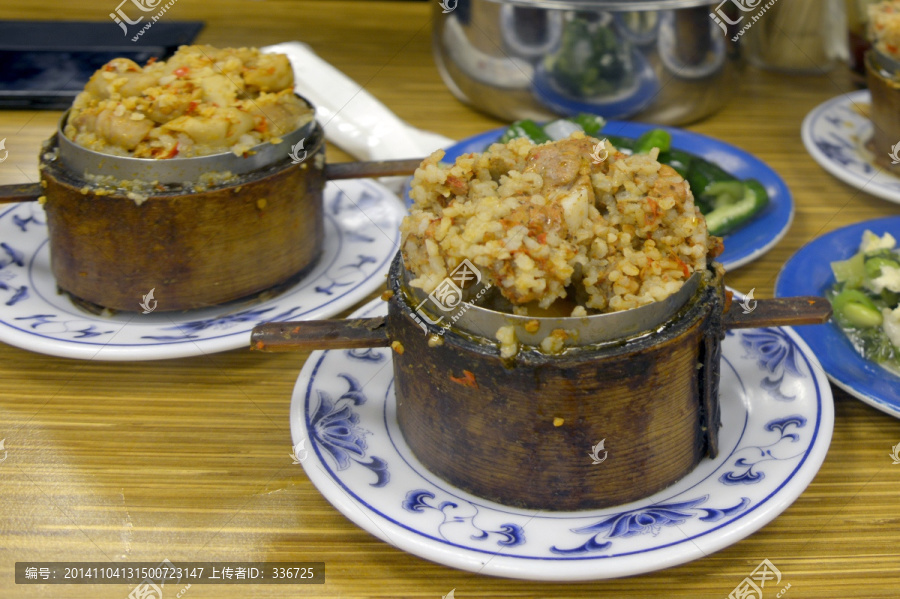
{"left": 261, "top": 42, "right": 454, "bottom": 165}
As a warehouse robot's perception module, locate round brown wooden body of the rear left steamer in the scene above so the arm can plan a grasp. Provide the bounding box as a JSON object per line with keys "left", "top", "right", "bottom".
{"left": 40, "top": 117, "right": 325, "bottom": 311}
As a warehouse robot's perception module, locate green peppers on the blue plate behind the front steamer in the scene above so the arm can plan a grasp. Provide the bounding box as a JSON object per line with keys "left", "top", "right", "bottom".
{"left": 500, "top": 114, "right": 769, "bottom": 235}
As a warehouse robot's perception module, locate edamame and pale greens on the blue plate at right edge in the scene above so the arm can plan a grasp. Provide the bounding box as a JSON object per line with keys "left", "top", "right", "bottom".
{"left": 826, "top": 231, "right": 900, "bottom": 375}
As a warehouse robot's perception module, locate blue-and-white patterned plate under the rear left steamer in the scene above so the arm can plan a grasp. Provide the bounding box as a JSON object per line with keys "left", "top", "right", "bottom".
{"left": 0, "top": 180, "right": 405, "bottom": 360}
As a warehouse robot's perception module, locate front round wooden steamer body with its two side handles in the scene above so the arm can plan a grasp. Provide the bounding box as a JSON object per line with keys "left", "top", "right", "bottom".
{"left": 251, "top": 253, "right": 830, "bottom": 511}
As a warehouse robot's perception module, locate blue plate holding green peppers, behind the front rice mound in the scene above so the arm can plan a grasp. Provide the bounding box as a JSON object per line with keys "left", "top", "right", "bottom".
{"left": 403, "top": 126, "right": 794, "bottom": 270}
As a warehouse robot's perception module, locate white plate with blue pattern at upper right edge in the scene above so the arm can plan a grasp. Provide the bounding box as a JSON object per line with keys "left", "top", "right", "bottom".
{"left": 801, "top": 90, "right": 900, "bottom": 203}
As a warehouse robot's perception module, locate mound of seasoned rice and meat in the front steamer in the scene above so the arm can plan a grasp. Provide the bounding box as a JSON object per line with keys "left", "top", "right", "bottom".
{"left": 401, "top": 133, "right": 721, "bottom": 315}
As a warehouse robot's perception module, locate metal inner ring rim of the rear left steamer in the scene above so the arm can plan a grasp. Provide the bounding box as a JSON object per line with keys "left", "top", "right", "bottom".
{"left": 57, "top": 99, "right": 316, "bottom": 184}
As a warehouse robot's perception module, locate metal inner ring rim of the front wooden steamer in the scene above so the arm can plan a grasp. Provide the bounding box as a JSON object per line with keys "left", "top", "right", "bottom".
{"left": 400, "top": 261, "right": 703, "bottom": 346}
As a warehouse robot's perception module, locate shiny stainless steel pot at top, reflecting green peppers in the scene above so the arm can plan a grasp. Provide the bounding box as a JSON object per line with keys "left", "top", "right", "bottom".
{"left": 432, "top": 0, "right": 741, "bottom": 125}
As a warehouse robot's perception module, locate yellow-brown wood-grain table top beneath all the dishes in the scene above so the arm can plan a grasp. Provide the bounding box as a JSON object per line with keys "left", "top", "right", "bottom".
{"left": 0, "top": 0, "right": 900, "bottom": 599}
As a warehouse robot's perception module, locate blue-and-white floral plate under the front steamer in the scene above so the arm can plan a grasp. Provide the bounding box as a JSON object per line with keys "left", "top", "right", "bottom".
{"left": 291, "top": 300, "right": 834, "bottom": 581}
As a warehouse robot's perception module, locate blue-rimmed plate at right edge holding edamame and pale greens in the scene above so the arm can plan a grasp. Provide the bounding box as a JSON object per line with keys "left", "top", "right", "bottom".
{"left": 775, "top": 216, "right": 900, "bottom": 418}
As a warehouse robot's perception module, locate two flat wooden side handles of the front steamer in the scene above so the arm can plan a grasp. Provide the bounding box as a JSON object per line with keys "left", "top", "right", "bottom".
{"left": 250, "top": 296, "right": 831, "bottom": 352}
